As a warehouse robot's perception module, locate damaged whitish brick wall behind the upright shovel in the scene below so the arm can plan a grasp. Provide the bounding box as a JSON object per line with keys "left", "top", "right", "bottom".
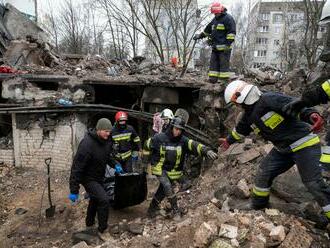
{"left": 13, "top": 115, "right": 86, "bottom": 170}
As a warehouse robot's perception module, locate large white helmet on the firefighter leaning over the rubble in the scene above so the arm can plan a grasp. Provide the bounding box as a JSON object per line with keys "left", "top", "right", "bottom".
{"left": 225, "top": 80, "right": 261, "bottom": 105}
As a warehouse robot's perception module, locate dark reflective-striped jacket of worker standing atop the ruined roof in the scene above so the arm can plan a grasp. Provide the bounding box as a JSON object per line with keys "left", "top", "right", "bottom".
{"left": 202, "top": 12, "right": 236, "bottom": 51}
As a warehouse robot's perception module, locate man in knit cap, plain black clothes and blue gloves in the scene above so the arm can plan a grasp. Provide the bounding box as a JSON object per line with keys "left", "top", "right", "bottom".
{"left": 69, "top": 118, "right": 120, "bottom": 241}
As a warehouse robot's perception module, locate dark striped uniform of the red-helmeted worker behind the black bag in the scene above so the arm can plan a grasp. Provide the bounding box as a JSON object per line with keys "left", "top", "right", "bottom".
{"left": 111, "top": 123, "right": 141, "bottom": 173}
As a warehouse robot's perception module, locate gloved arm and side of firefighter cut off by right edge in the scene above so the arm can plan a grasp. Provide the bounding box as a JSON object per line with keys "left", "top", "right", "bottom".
{"left": 283, "top": 80, "right": 330, "bottom": 176}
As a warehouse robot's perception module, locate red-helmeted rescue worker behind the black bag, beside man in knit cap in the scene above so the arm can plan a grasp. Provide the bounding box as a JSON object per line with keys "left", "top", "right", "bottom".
{"left": 111, "top": 111, "right": 141, "bottom": 173}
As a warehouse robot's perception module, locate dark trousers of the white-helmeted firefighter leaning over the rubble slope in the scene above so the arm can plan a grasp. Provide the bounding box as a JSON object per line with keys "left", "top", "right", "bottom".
{"left": 252, "top": 144, "right": 330, "bottom": 217}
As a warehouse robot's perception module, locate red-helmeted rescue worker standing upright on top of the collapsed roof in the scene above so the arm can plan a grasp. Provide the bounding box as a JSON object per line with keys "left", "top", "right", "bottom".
{"left": 194, "top": 2, "right": 236, "bottom": 83}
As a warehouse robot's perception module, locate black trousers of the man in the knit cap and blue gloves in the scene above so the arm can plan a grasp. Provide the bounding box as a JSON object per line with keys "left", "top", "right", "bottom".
{"left": 83, "top": 181, "right": 110, "bottom": 232}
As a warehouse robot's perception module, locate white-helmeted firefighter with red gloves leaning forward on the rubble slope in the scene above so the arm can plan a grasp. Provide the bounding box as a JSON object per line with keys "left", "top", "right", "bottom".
{"left": 219, "top": 80, "right": 330, "bottom": 227}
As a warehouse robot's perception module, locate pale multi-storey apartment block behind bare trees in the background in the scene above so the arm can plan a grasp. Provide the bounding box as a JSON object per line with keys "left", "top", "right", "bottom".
{"left": 247, "top": 0, "right": 322, "bottom": 70}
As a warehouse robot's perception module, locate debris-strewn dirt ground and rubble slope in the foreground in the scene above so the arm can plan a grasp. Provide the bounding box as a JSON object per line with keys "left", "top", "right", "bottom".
{"left": 0, "top": 139, "right": 330, "bottom": 248}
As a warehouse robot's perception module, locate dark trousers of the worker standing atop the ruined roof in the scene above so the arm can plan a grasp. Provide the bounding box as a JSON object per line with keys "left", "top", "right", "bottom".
{"left": 208, "top": 49, "right": 231, "bottom": 83}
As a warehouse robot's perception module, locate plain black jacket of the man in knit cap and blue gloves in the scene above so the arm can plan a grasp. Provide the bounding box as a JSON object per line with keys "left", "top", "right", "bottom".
{"left": 70, "top": 129, "right": 116, "bottom": 194}
